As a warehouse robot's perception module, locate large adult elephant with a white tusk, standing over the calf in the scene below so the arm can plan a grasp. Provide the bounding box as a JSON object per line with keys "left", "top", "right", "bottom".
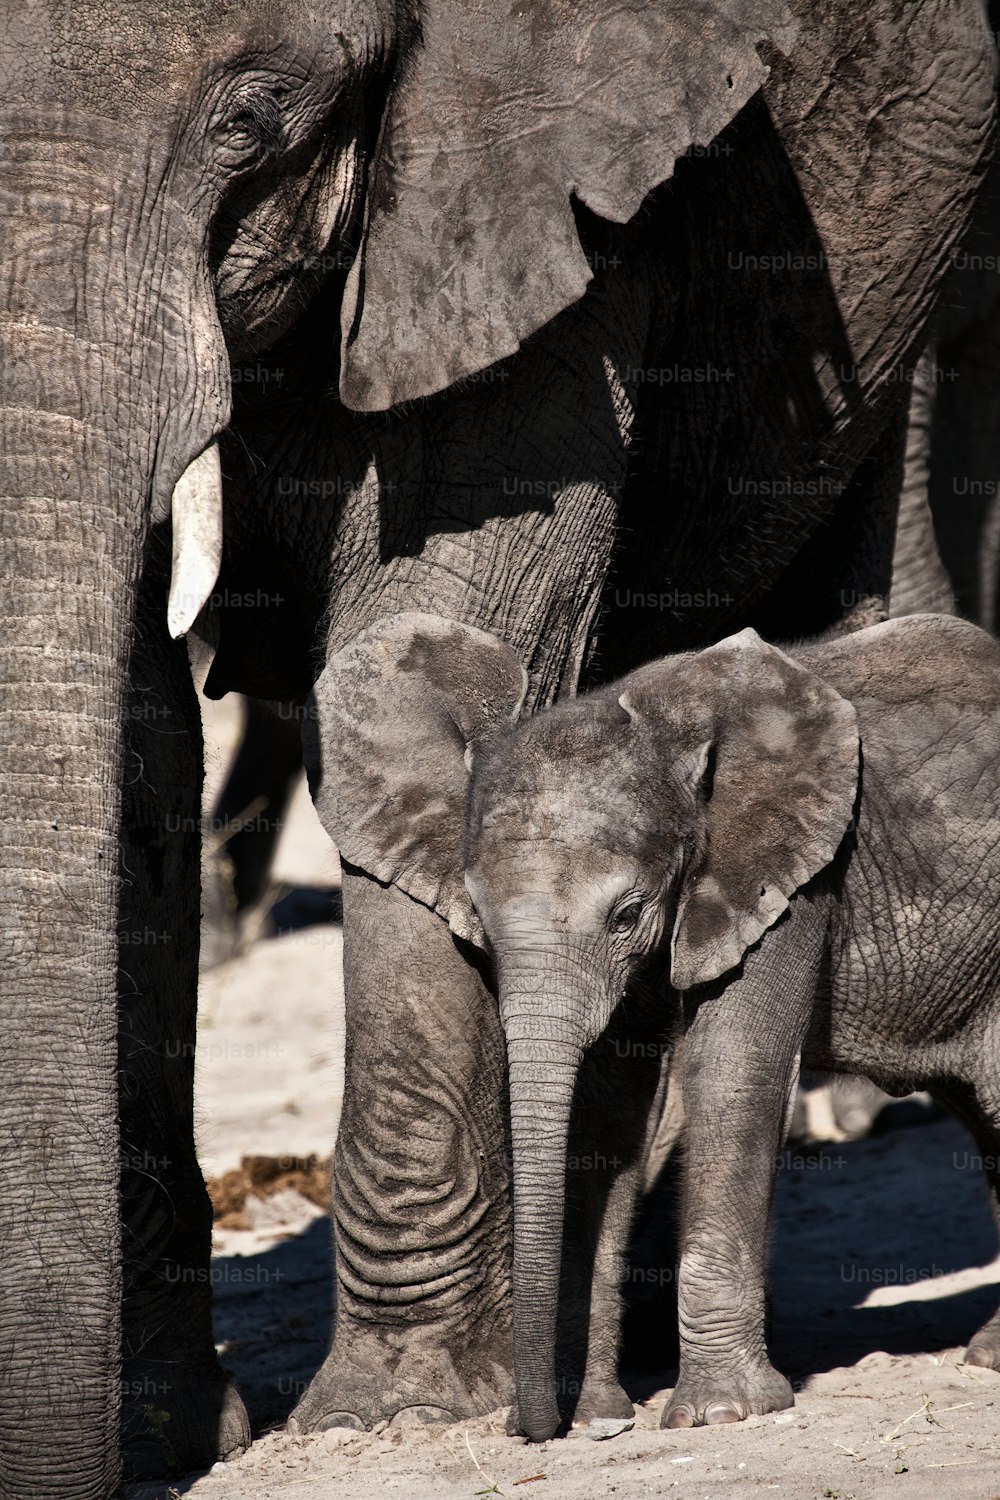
{"left": 0, "top": 0, "right": 993, "bottom": 1500}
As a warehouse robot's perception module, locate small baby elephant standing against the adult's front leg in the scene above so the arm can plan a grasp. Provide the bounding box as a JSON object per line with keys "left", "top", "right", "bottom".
{"left": 318, "top": 615, "right": 1000, "bottom": 1440}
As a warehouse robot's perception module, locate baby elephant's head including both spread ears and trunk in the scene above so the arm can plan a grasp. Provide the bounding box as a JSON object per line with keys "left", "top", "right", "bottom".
{"left": 313, "top": 615, "right": 858, "bottom": 1439}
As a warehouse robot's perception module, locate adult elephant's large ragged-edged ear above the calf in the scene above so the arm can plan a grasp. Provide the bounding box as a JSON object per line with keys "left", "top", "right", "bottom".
{"left": 340, "top": 0, "right": 796, "bottom": 411}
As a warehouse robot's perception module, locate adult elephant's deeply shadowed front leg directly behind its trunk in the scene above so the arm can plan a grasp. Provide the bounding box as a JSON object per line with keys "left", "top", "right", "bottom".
{"left": 118, "top": 555, "right": 249, "bottom": 1476}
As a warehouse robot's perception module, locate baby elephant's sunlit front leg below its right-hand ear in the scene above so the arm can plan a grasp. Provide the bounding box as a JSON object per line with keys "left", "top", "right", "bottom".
{"left": 663, "top": 899, "right": 822, "bottom": 1427}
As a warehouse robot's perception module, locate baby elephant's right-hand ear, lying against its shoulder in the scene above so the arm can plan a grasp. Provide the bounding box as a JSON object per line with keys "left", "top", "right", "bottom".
{"left": 621, "top": 630, "right": 859, "bottom": 990}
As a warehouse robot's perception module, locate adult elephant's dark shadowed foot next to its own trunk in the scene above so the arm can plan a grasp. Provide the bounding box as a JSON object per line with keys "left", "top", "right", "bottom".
{"left": 121, "top": 1361, "right": 250, "bottom": 1481}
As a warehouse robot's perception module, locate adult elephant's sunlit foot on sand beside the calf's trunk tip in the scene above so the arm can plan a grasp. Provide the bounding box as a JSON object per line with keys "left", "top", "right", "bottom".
{"left": 286, "top": 1335, "right": 513, "bottom": 1433}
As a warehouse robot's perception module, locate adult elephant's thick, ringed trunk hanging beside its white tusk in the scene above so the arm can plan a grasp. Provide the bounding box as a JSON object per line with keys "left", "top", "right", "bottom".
{"left": 0, "top": 135, "right": 226, "bottom": 1500}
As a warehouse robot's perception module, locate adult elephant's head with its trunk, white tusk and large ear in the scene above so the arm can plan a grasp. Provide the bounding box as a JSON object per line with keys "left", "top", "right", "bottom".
{"left": 0, "top": 0, "right": 792, "bottom": 1497}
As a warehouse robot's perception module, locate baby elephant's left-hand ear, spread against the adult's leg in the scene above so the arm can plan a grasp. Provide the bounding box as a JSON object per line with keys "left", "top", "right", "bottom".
{"left": 310, "top": 614, "right": 528, "bottom": 945}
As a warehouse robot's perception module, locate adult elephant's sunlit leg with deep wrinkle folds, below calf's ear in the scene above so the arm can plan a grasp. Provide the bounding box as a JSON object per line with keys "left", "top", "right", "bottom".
{"left": 289, "top": 866, "right": 513, "bottom": 1431}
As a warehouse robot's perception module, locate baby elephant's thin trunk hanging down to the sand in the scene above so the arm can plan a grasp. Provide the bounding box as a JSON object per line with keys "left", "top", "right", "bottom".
{"left": 499, "top": 963, "right": 583, "bottom": 1442}
